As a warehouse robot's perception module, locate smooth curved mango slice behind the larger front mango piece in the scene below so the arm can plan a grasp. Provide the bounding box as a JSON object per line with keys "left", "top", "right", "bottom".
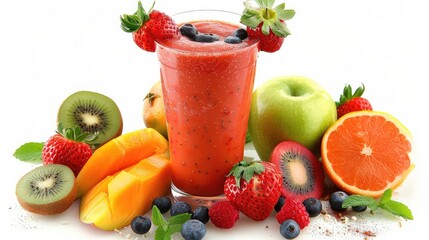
{"left": 76, "top": 128, "right": 168, "bottom": 198}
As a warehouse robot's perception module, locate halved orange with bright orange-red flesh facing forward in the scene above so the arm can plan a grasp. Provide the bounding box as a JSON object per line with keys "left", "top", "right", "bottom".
{"left": 321, "top": 111, "right": 414, "bottom": 197}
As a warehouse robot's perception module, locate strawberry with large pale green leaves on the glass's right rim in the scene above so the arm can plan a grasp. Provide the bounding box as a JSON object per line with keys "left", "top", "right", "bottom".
{"left": 240, "top": 0, "right": 295, "bottom": 52}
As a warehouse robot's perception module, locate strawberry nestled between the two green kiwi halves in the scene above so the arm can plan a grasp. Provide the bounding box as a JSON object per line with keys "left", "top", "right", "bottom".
{"left": 42, "top": 124, "right": 97, "bottom": 176}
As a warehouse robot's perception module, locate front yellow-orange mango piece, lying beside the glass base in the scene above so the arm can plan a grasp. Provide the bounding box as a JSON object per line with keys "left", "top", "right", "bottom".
{"left": 79, "top": 154, "right": 171, "bottom": 230}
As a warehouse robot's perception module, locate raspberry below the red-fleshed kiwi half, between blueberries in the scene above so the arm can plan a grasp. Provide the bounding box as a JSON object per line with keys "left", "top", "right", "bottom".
{"left": 276, "top": 197, "right": 310, "bottom": 229}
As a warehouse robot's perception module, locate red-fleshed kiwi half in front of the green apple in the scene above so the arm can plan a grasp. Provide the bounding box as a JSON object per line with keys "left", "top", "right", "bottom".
{"left": 270, "top": 141, "right": 325, "bottom": 202}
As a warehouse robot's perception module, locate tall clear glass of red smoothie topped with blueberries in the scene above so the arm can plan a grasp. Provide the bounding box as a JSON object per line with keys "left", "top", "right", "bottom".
{"left": 156, "top": 10, "right": 258, "bottom": 203}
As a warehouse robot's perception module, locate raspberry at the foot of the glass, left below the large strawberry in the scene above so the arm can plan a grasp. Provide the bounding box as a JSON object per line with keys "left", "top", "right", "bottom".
{"left": 209, "top": 200, "right": 239, "bottom": 228}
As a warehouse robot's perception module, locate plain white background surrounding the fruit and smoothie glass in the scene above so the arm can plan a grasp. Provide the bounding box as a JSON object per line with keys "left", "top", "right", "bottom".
{"left": 0, "top": 0, "right": 429, "bottom": 239}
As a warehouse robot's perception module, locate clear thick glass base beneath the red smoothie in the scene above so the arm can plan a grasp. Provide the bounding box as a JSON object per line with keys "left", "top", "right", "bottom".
{"left": 171, "top": 184, "right": 226, "bottom": 209}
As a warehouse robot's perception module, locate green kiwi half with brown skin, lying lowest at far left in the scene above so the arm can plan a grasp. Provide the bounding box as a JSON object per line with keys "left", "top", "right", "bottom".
{"left": 16, "top": 164, "right": 77, "bottom": 215}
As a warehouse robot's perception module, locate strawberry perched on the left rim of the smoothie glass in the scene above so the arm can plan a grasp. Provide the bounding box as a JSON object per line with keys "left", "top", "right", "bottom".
{"left": 121, "top": 1, "right": 179, "bottom": 52}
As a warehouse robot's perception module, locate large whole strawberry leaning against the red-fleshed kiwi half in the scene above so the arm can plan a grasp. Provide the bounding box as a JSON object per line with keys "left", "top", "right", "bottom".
{"left": 224, "top": 160, "right": 282, "bottom": 221}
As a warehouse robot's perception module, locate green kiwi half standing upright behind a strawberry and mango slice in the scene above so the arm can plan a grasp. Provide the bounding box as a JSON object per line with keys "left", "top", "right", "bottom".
{"left": 57, "top": 91, "right": 122, "bottom": 148}
